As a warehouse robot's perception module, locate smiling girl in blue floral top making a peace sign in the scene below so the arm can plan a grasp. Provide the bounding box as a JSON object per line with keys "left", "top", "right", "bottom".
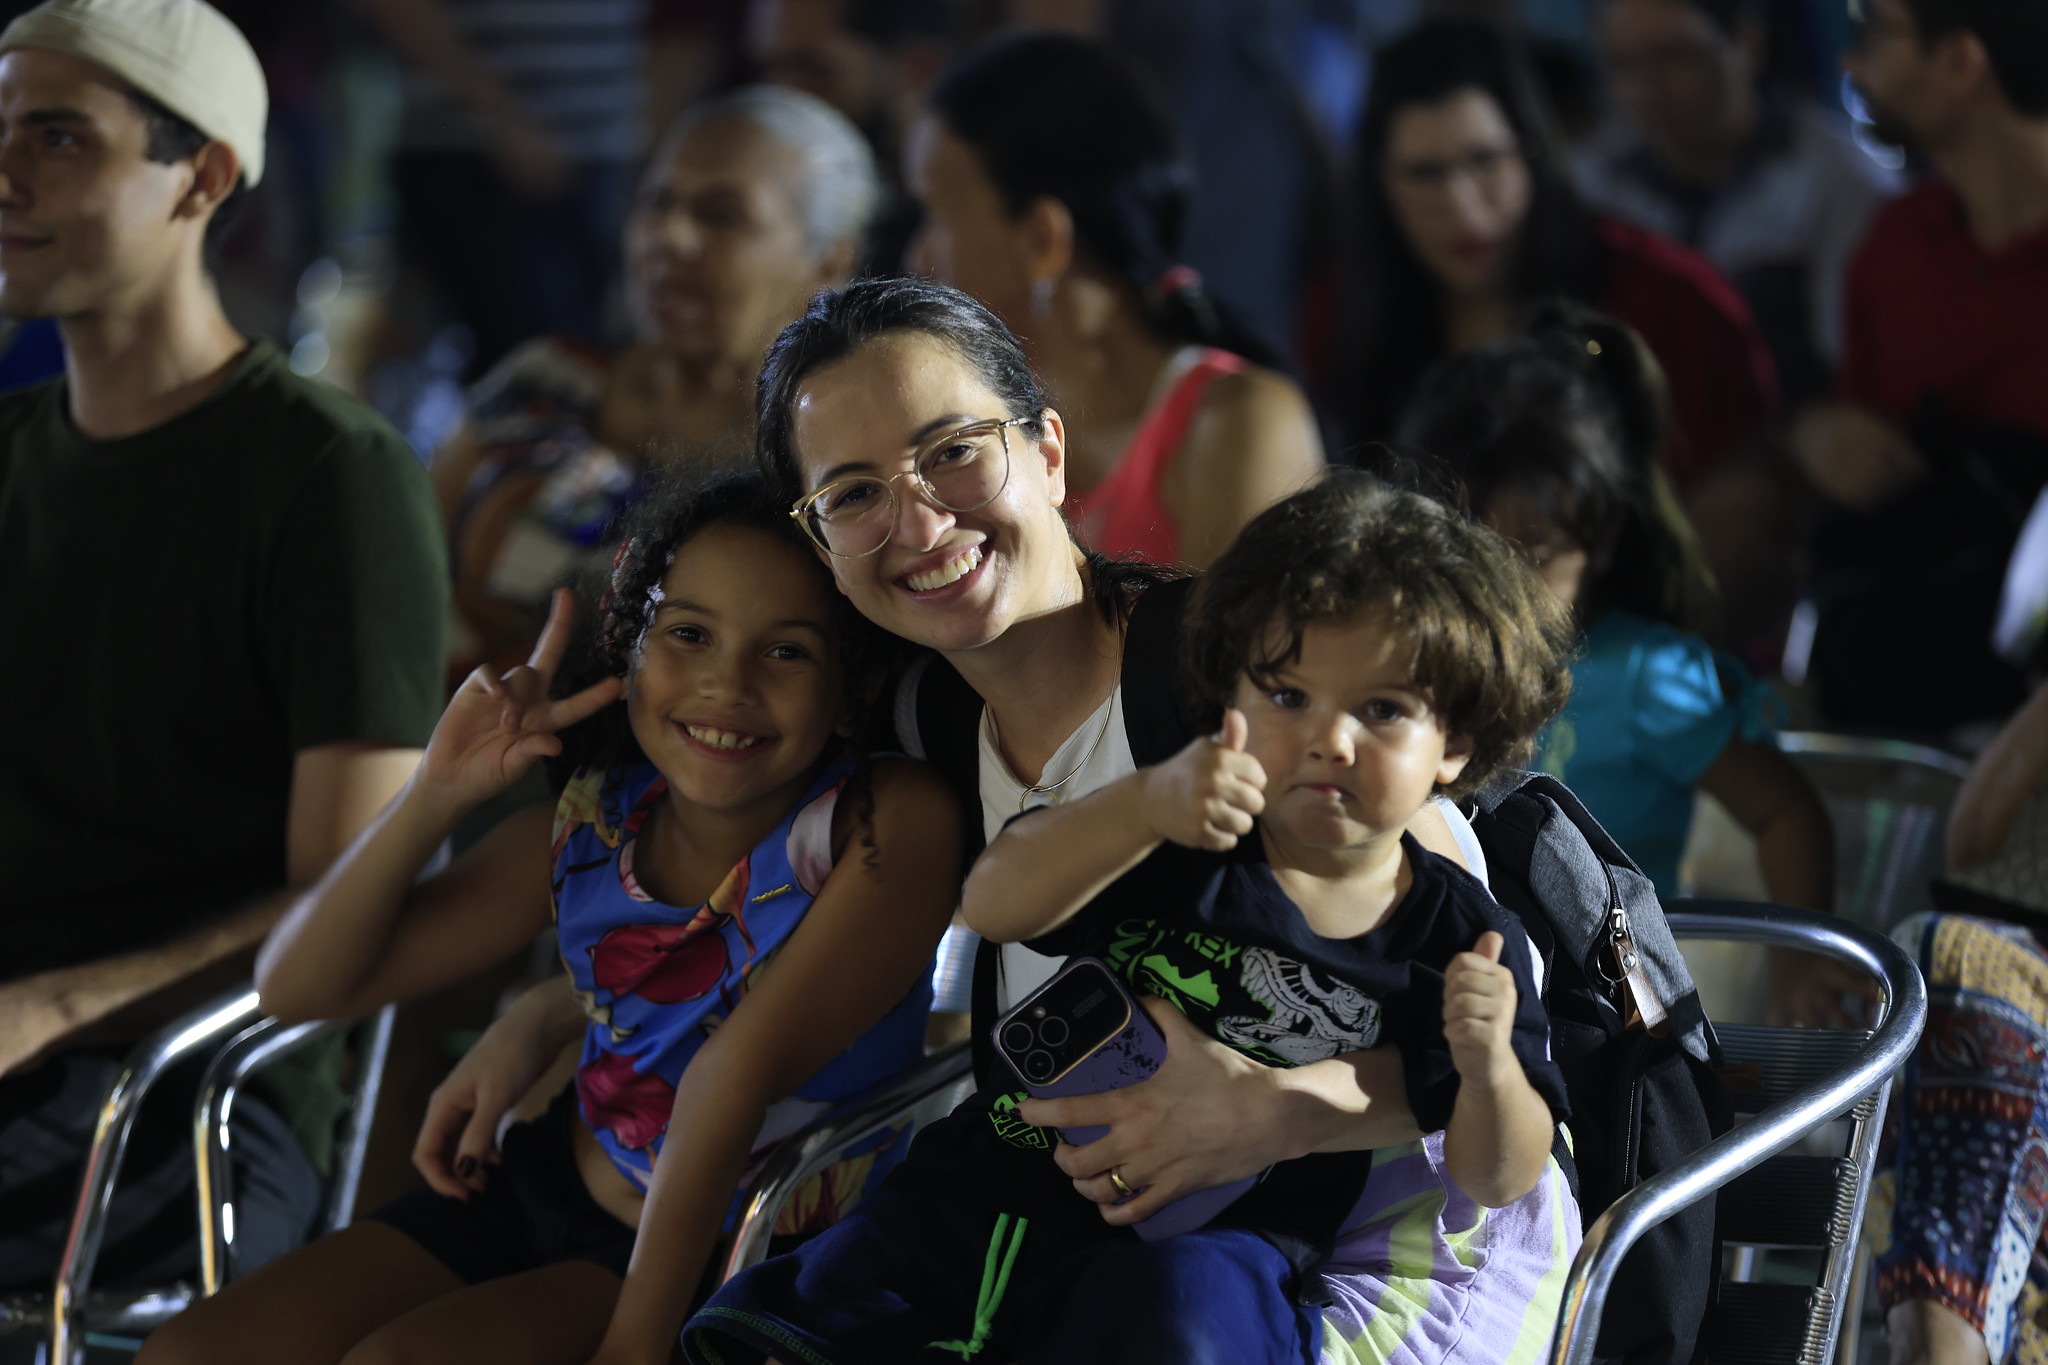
{"left": 139, "top": 473, "right": 961, "bottom": 1365}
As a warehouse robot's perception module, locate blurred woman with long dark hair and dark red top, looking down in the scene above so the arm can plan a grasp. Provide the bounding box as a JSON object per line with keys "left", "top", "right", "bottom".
{"left": 1331, "top": 20, "right": 1778, "bottom": 489}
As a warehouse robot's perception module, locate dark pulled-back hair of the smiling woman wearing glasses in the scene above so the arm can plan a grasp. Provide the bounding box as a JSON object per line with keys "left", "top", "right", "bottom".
{"left": 754, "top": 276, "right": 1171, "bottom": 622}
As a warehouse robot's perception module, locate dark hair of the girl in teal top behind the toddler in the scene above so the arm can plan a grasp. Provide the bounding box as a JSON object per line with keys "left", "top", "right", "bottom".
{"left": 1401, "top": 301, "right": 1714, "bottom": 630}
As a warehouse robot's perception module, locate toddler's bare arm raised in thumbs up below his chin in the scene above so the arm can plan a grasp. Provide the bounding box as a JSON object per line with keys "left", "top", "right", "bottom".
{"left": 961, "top": 710, "right": 1266, "bottom": 943}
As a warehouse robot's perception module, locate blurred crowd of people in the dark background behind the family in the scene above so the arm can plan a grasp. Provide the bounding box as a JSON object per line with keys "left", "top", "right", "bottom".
{"left": 0, "top": 0, "right": 2015, "bottom": 739}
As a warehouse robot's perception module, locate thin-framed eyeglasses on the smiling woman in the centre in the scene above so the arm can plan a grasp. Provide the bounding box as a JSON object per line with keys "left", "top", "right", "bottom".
{"left": 788, "top": 417, "right": 1030, "bottom": 559}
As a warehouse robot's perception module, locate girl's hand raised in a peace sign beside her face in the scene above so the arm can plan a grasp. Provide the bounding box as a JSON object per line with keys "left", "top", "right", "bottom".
{"left": 420, "top": 587, "right": 625, "bottom": 808}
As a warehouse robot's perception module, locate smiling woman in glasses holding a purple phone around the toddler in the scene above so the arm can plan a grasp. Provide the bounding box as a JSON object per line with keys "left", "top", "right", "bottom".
{"left": 686, "top": 280, "right": 1577, "bottom": 1365}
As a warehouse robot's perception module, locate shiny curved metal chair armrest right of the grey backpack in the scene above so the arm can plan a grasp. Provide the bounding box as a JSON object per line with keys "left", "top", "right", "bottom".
{"left": 1550, "top": 900, "right": 1927, "bottom": 1365}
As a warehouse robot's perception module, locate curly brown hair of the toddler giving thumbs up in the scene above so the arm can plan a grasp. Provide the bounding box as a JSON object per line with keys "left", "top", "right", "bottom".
{"left": 1182, "top": 471, "right": 1573, "bottom": 800}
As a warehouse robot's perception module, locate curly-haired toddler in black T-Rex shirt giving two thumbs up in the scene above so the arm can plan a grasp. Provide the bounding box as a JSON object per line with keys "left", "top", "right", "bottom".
{"left": 684, "top": 475, "right": 1577, "bottom": 1365}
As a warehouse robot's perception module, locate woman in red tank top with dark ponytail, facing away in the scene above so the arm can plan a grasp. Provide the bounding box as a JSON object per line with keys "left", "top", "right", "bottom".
{"left": 907, "top": 33, "right": 1323, "bottom": 567}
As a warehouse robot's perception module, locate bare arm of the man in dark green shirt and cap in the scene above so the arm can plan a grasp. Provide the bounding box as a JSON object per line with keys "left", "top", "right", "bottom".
{"left": 0, "top": 743, "right": 420, "bottom": 1074}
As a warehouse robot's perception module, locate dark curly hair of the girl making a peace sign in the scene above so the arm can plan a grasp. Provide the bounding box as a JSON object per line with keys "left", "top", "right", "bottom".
{"left": 549, "top": 467, "right": 901, "bottom": 786}
